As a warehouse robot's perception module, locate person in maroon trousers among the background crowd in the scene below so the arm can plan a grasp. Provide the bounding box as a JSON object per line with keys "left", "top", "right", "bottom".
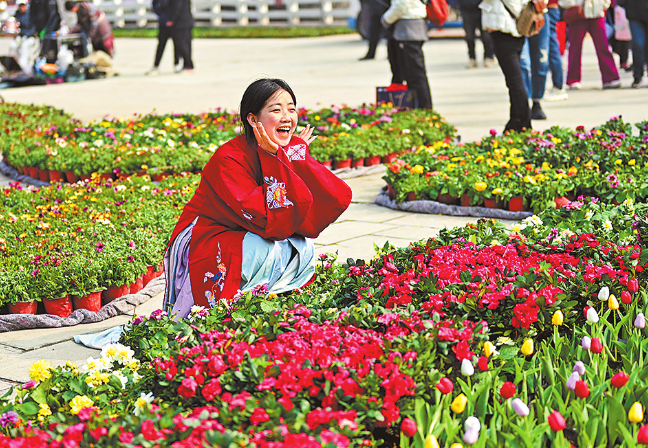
{"left": 558, "top": 0, "right": 621, "bottom": 89}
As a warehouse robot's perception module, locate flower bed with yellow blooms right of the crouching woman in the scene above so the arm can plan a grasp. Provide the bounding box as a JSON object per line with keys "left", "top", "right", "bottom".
{"left": 385, "top": 118, "right": 648, "bottom": 212}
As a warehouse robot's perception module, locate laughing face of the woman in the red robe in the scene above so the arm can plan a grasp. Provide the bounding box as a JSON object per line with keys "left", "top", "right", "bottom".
{"left": 248, "top": 89, "right": 297, "bottom": 146}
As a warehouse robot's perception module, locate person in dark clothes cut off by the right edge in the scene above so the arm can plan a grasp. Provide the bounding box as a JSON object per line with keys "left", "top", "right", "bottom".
{"left": 617, "top": 0, "right": 648, "bottom": 89}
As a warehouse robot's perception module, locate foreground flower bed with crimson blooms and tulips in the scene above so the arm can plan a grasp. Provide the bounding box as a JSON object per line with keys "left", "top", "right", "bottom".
{"left": 0, "top": 198, "right": 648, "bottom": 448}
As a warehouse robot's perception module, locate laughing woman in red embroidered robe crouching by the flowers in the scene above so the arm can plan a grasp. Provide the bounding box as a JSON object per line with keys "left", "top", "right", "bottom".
{"left": 164, "top": 79, "right": 351, "bottom": 318}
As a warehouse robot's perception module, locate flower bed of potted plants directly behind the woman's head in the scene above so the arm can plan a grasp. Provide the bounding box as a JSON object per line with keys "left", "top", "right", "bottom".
{"left": 0, "top": 103, "right": 455, "bottom": 178}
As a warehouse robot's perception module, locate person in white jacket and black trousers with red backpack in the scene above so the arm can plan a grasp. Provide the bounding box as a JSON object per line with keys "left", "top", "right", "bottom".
{"left": 381, "top": 0, "right": 432, "bottom": 109}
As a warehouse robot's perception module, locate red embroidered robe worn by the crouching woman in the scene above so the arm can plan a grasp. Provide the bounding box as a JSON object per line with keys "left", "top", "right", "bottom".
{"left": 169, "top": 135, "right": 351, "bottom": 306}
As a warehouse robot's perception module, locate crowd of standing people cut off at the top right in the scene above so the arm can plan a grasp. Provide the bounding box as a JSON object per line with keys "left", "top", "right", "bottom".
{"left": 361, "top": 0, "right": 648, "bottom": 131}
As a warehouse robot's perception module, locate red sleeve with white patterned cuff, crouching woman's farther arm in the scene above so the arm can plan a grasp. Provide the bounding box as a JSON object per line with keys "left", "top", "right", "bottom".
{"left": 277, "top": 138, "right": 352, "bottom": 238}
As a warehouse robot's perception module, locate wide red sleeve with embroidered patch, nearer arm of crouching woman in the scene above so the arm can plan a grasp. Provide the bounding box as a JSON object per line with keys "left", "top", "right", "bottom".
{"left": 203, "top": 151, "right": 313, "bottom": 240}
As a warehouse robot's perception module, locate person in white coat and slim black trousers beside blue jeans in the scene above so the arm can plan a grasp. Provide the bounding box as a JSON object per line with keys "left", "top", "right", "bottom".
{"left": 479, "top": 0, "right": 531, "bottom": 132}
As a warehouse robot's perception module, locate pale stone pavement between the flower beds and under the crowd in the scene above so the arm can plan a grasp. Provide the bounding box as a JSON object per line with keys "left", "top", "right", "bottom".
{"left": 0, "top": 35, "right": 648, "bottom": 391}
